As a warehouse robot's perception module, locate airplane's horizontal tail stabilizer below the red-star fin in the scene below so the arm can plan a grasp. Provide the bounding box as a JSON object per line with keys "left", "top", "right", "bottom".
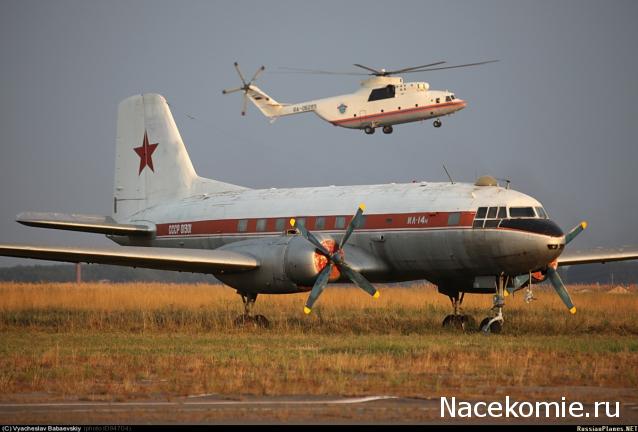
{"left": 16, "top": 212, "right": 155, "bottom": 236}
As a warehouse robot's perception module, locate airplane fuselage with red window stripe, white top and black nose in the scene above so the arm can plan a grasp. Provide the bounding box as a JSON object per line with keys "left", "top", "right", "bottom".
{"left": 112, "top": 182, "right": 565, "bottom": 293}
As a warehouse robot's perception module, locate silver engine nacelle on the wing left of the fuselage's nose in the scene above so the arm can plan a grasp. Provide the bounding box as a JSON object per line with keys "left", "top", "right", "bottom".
{"left": 215, "top": 236, "right": 339, "bottom": 294}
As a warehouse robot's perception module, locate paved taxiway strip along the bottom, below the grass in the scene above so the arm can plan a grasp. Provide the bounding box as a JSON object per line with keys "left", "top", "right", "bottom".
{"left": 0, "top": 395, "right": 638, "bottom": 424}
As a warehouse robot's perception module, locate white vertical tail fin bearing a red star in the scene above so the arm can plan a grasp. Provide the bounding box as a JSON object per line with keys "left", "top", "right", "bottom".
{"left": 113, "top": 94, "right": 243, "bottom": 222}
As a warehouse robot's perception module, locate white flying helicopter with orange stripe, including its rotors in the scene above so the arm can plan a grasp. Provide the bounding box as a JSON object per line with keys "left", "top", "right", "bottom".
{"left": 222, "top": 60, "right": 498, "bottom": 135}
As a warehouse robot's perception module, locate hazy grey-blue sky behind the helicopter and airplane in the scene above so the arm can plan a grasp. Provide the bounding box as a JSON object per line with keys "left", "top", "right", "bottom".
{"left": 0, "top": 0, "right": 638, "bottom": 265}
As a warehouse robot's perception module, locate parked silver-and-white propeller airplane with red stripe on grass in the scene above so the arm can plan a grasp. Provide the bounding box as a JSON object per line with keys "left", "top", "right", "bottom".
{"left": 0, "top": 94, "right": 638, "bottom": 333}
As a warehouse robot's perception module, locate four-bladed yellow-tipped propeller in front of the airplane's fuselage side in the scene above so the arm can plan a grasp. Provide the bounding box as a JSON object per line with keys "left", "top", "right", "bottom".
{"left": 290, "top": 204, "right": 379, "bottom": 314}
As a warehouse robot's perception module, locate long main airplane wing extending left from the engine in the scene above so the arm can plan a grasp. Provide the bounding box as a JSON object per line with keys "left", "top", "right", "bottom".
{"left": 0, "top": 244, "right": 259, "bottom": 274}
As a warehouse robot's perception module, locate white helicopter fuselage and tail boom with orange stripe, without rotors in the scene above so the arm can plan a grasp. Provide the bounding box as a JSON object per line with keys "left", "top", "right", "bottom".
{"left": 247, "top": 76, "right": 467, "bottom": 131}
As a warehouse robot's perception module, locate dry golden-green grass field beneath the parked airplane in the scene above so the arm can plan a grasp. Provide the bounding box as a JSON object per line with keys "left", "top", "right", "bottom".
{"left": 0, "top": 283, "right": 638, "bottom": 401}
